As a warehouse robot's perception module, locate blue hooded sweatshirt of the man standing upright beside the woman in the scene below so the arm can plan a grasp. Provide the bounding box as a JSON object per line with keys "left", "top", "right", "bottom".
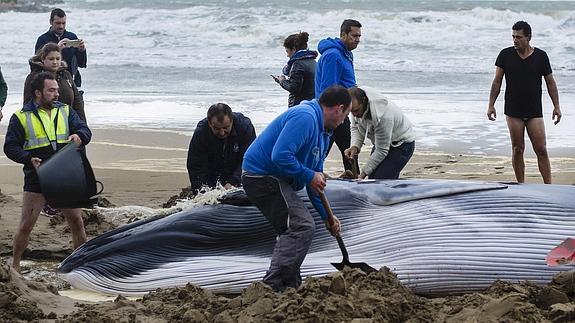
{"left": 315, "top": 38, "right": 356, "bottom": 99}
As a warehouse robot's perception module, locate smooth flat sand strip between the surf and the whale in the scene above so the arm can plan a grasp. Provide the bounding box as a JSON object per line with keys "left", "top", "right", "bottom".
{"left": 0, "top": 123, "right": 575, "bottom": 202}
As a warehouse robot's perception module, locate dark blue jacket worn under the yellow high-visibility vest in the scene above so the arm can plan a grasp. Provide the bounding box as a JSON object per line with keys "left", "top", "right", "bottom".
{"left": 4, "top": 101, "right": 92, "bottom": 169}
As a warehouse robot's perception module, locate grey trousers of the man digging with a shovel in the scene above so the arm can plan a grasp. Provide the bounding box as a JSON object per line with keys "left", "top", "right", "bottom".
{"left": 242, "top": 173, "right": 315, "bottom": 292}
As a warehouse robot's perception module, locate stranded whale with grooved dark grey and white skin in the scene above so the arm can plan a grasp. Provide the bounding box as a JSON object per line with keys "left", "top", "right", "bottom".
{"left": 58, "top": 180, "right": 575, "bottom": 296}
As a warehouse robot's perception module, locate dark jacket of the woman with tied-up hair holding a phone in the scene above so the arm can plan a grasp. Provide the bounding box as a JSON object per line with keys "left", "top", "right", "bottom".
{"left": 280, "top": 58, "right": 316, "bottom": 107}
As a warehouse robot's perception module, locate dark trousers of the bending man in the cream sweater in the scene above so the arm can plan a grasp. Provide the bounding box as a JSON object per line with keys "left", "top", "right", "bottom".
{"left": 369, "top": 141, "right": 415, "bottom": 179}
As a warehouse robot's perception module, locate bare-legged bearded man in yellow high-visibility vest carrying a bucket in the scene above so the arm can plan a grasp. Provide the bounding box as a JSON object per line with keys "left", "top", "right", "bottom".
{"left": 4, "top": 72, "right": 92, "bottom": 272}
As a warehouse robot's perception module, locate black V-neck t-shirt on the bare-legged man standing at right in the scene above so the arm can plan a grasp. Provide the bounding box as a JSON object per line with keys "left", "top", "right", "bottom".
{"left": 495, "top": 47, "right": 551, "bottom": 118}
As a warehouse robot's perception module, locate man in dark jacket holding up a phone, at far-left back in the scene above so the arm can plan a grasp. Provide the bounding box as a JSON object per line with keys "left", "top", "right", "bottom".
{"left": 34, "top": 8, "right": 88, "bottom": 88}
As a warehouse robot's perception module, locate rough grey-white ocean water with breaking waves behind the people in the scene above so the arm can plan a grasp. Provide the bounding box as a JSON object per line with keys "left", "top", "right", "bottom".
{"left": 0, "top": 0, "right": 575, "bottom": 156}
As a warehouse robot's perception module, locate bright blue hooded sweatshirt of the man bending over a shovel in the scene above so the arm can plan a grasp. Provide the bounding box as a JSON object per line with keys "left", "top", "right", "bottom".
{"left": 242, "top": 99, "right": 331, "bottom": 220}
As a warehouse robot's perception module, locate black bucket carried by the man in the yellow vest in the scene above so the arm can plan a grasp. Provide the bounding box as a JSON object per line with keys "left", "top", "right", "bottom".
{"left": 37, "top": 142, "right": 104, "bottom": 209}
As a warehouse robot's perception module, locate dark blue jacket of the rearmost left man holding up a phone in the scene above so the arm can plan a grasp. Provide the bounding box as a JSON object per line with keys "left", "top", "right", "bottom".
{"left": 34, "top": 30, "right": 88, "bottom": 87}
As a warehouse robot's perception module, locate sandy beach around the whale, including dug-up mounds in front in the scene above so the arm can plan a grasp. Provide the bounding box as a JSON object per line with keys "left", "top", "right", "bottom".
{"left": 0, "top": 125, "right": 575, "bottom": 322}
